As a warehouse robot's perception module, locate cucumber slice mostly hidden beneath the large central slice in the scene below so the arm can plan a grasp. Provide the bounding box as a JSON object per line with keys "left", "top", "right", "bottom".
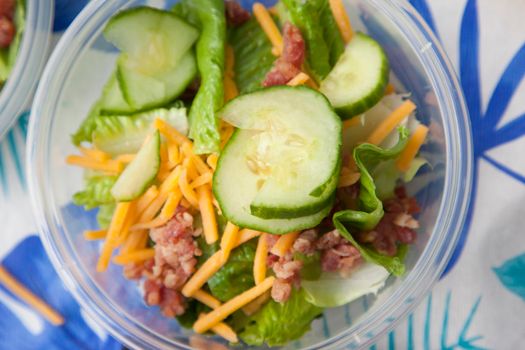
{"left": 212, "top": 130, "right": 333, "bottom": 234}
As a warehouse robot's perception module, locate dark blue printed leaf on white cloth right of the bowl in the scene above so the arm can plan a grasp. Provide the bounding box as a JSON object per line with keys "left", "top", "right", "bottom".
{"left": 410, "top": 0, "right": 525, "bottom": 275}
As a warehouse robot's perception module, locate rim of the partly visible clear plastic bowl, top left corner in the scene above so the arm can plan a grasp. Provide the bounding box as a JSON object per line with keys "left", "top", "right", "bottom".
{"left": 0, "top": 0, "right": 54, "bottom": 138}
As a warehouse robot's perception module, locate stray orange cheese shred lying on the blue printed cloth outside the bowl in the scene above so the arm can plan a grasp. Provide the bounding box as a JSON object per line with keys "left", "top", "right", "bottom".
{"left": 0, "top": 266, "right": 64, "bottom": 326}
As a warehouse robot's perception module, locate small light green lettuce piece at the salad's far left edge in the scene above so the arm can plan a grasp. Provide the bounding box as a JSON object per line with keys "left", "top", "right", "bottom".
{"left": 73, "top": 176, "right": 117, "bottom": 210}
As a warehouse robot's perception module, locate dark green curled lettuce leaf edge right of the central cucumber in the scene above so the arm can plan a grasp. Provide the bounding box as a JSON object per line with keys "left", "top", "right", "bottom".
{"left": 333, "top": 127, "right": 408, "bottom": 276}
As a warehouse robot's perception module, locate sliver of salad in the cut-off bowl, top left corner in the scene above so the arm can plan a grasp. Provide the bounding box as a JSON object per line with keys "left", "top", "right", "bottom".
{"left": 0, "top": 0, "right": 25, "bottom": 86}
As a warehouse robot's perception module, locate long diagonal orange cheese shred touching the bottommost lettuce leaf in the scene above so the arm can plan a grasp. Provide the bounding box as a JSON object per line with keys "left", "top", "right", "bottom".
{"left": 193, "top": 276, "right": 275, "bottom": 333}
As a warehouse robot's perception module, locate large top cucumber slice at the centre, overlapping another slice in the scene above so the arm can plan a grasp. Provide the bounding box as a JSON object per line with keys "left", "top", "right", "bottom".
{"left": 215, "top": 86, "right": 342, "bottom": 219}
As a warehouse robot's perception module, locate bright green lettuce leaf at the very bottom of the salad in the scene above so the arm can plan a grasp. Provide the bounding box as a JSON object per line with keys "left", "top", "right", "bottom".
{"left": 233, "top": 289, "right": 323, "bottom": 346}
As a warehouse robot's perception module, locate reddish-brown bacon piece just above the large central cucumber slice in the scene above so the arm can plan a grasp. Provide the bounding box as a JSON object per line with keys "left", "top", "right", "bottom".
{"left": 263, "top": 22, "right": 305, "bottom": 87}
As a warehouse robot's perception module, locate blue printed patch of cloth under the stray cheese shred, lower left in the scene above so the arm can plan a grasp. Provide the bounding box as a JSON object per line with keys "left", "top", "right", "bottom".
{"left": 0, "top": 236, "right": 121, "bottom": 350}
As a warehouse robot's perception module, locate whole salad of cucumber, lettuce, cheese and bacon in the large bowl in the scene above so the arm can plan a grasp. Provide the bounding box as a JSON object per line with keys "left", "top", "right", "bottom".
{"left": 67, "top": 0, "right": 428, "bottom": 346}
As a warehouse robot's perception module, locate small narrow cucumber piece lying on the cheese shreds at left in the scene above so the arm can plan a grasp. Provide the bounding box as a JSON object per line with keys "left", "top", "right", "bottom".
{"left": 111, "top": 131, "right": 160, "bottom": 202}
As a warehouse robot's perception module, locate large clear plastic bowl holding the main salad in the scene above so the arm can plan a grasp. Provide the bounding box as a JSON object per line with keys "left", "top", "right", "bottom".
{"left": 27, "top": 0, "right": 472, "bottom": 349}
